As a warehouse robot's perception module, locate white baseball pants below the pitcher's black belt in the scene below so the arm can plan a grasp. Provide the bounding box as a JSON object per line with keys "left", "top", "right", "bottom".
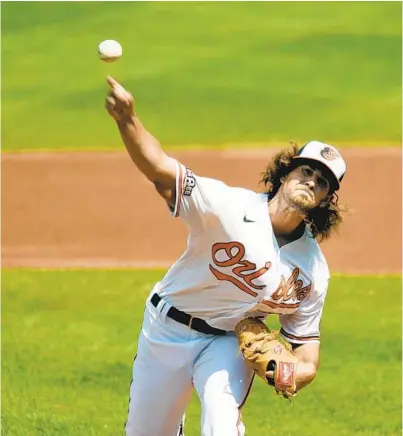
{"left": 125, "top": 300, "right": 253, "bottom": 436}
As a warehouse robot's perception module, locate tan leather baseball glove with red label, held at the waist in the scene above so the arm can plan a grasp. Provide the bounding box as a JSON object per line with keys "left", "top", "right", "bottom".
{"left": 235, "top": 318, "right": 298, "bottom": 400}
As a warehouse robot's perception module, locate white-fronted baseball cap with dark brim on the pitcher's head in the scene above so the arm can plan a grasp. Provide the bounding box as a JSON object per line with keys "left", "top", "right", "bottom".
{"left": 294, "top": 141, "right": 347, "bottom": 190}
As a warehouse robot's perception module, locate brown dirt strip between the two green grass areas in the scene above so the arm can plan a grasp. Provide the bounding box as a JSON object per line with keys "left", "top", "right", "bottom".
{"left": 2, "top": 148, "right": 402, "bottom": 274}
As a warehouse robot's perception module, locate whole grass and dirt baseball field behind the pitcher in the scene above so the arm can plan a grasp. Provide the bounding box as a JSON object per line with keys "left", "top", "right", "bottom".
{"left": 1, "top": 2, "right": 402, "bottom": 436}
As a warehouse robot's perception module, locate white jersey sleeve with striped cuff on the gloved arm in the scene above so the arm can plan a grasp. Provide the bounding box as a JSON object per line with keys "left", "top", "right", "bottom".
{"left": 280, "top": 281, "right": 328, "bottom": 344}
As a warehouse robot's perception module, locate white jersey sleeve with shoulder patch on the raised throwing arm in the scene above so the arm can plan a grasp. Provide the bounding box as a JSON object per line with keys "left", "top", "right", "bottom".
{"left": 171, "top": 162, "right": 237, "bottom": 233}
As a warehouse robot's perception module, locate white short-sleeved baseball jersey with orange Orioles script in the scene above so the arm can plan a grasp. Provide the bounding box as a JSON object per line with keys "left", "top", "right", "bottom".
{"left": 152, "top": 163, "right": 329, "bottom": 343}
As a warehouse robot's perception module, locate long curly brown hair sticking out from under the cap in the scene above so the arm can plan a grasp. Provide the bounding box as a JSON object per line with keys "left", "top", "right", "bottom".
{"left": 260, "top": 142, "right": 347, "bottom": 242}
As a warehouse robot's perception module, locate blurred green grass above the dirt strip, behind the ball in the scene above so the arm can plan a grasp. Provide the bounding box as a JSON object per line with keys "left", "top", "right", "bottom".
{"left": 1, "top": 2, "right": 402, "bottom": 151}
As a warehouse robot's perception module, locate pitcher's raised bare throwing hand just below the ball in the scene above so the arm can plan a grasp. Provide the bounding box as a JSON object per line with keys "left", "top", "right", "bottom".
{"left": 105, "top": 76, "right": 134, "bottom": 121}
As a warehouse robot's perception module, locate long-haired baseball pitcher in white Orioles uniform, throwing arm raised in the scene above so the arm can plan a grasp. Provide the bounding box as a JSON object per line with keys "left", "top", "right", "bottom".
{"left": 106, "top": 77, "right": 346, "bottom": 436}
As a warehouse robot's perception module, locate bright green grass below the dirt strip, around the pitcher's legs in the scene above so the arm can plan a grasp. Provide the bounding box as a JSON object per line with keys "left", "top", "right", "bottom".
{"left": 2, "top": 270, "right": 402, "bottom": 436}
